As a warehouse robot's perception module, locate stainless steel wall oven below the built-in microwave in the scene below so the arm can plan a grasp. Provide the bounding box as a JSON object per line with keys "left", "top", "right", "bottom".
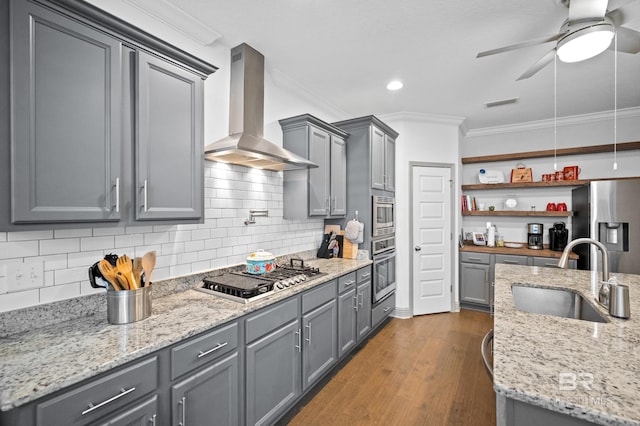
{"left": 371, "top": 235, "right": 396, "bottom": 303}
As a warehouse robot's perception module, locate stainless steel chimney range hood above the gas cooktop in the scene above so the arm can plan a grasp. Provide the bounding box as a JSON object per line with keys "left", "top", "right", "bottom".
{"left": 204, "top": 43, "right": 318, "bottom": 171}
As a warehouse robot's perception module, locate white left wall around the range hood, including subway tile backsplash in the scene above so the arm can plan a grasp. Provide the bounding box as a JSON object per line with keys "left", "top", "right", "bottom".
{"left": 0, "top": 0, "right": 347, "bottom": 312}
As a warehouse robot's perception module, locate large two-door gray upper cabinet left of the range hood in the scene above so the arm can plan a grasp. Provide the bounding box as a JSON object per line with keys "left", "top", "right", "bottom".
{"left": 0, "top": 0, "right": 216, "bottom": 230}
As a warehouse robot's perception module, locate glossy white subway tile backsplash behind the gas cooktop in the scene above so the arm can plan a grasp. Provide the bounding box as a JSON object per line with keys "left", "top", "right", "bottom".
{"left": 0, "top": 163, "right": 323, "bottom": 311}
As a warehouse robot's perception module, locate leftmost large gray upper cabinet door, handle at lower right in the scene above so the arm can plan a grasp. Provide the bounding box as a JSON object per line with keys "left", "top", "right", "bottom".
{"left": 10, "top": 1, "right": 121, "bottom": 223}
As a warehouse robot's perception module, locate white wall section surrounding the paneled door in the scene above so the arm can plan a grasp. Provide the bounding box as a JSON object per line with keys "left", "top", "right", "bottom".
{"left": 379, "top": 113, "right": 461, "bottom": 317}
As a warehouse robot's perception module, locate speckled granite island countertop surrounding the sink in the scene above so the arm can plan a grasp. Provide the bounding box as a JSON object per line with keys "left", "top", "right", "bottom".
{"left": 493, "top": 264, "right": 640, "bottom": 425}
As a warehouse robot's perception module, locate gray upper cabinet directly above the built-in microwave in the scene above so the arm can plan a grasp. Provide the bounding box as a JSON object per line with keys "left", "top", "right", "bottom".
{"left": 333, "top": 115, "right": 398, "bottom": 192}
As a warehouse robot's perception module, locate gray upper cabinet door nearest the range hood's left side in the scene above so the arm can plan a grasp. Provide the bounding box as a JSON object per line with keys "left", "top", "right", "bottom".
{"left": 135, "top": 52, "right": 204, "bottom": 220}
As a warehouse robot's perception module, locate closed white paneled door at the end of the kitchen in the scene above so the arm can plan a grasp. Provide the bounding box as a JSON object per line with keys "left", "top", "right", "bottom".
{"left": 411, "top": 166, "right": 453, "bottom": 315}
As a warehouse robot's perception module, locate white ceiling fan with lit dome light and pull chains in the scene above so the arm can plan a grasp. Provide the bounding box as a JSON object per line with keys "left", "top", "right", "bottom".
{"left": 476, "top": 0, "right": 640, "bottom": 80}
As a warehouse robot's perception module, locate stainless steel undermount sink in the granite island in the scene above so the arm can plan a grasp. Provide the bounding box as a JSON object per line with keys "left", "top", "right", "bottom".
{"left": 511, "top": 284, "right": 609, "bottom": 322}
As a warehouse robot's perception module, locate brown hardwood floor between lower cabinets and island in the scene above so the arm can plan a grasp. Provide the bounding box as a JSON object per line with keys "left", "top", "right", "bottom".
{"left": 289, "top": 310, "right": 496, "bottom": 426}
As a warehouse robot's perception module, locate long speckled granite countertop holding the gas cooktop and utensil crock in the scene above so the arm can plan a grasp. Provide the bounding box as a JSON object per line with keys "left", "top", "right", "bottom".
{"left": 0, "top": 255, "right": 372, "bottom": 411}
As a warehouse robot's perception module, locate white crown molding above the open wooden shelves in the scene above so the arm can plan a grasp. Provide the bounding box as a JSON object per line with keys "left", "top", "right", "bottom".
{"left": 465, "top": 107, "right": 640, "bottom": 139}
